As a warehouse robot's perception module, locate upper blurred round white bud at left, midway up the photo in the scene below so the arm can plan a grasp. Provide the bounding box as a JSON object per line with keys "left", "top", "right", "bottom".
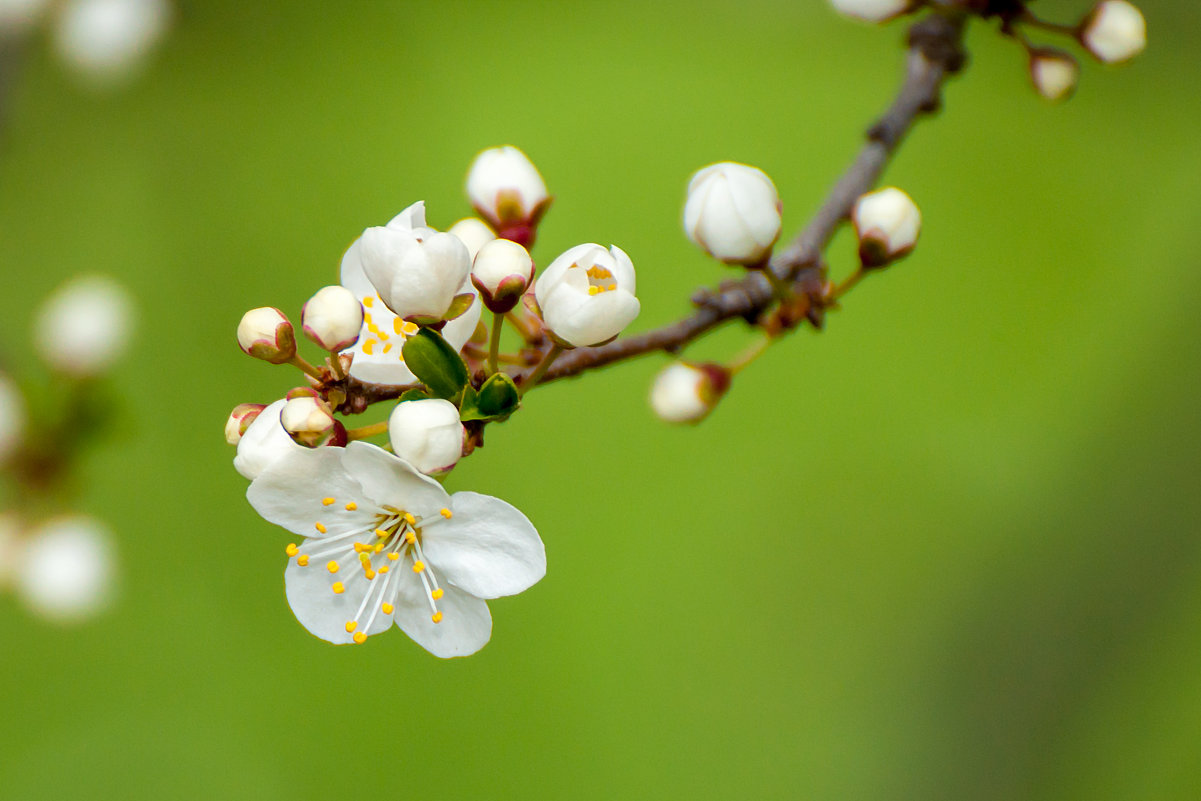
{"left": 34, "top": 275, "right": 133, "bottom": 378}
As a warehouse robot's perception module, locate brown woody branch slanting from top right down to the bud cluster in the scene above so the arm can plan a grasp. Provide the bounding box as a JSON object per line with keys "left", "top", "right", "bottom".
{"left": 539, "top": 13, "right": 964, "bottom": 383}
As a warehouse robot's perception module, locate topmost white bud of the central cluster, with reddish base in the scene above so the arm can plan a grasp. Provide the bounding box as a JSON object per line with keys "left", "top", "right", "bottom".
{"left": 467, "top": 144, "right": 550, "bottom": 245}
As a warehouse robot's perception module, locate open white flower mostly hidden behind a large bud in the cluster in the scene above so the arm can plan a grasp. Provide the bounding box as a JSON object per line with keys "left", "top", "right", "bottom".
{"left": 341, "top": 202, "right": 482, "bottom": 384}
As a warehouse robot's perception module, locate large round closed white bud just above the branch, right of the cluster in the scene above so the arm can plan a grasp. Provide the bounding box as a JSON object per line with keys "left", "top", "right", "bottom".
{"left": 683, "top": 161, "right": 781, "bottom": 267}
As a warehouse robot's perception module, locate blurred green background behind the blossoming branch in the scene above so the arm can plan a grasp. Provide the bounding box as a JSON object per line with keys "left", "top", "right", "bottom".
{"left": 0, "top": 0, "right": 1201, "bottom": 801}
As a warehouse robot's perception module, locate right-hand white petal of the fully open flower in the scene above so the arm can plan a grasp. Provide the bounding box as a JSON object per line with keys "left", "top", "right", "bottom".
{"left": 422, "top": 492, "right": 546, "bottom": 598}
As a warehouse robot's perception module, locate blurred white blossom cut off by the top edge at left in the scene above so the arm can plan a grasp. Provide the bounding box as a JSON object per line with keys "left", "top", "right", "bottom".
{"left": 55, "top": 0, "right": 171, "bottom": 83}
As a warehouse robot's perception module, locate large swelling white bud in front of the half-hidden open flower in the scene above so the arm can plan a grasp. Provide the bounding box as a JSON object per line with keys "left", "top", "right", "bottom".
{"left": 359, "top": 226, "right": 471, "bottom": 323}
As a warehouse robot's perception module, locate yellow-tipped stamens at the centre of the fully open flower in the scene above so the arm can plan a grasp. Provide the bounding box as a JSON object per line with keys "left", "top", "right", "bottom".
{"left": 286, "top": 497, "right": 452, "bottom": 644}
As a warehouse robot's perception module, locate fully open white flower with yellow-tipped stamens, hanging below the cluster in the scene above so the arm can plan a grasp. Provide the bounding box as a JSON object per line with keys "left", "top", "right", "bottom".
{"left": 246, "top": 442, "right": 546, "bottom": 658}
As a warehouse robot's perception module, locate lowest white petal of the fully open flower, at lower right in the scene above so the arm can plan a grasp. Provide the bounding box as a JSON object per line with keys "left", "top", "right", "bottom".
{"left": 395, "top": 576, "right": 492, "bottom": 659}
